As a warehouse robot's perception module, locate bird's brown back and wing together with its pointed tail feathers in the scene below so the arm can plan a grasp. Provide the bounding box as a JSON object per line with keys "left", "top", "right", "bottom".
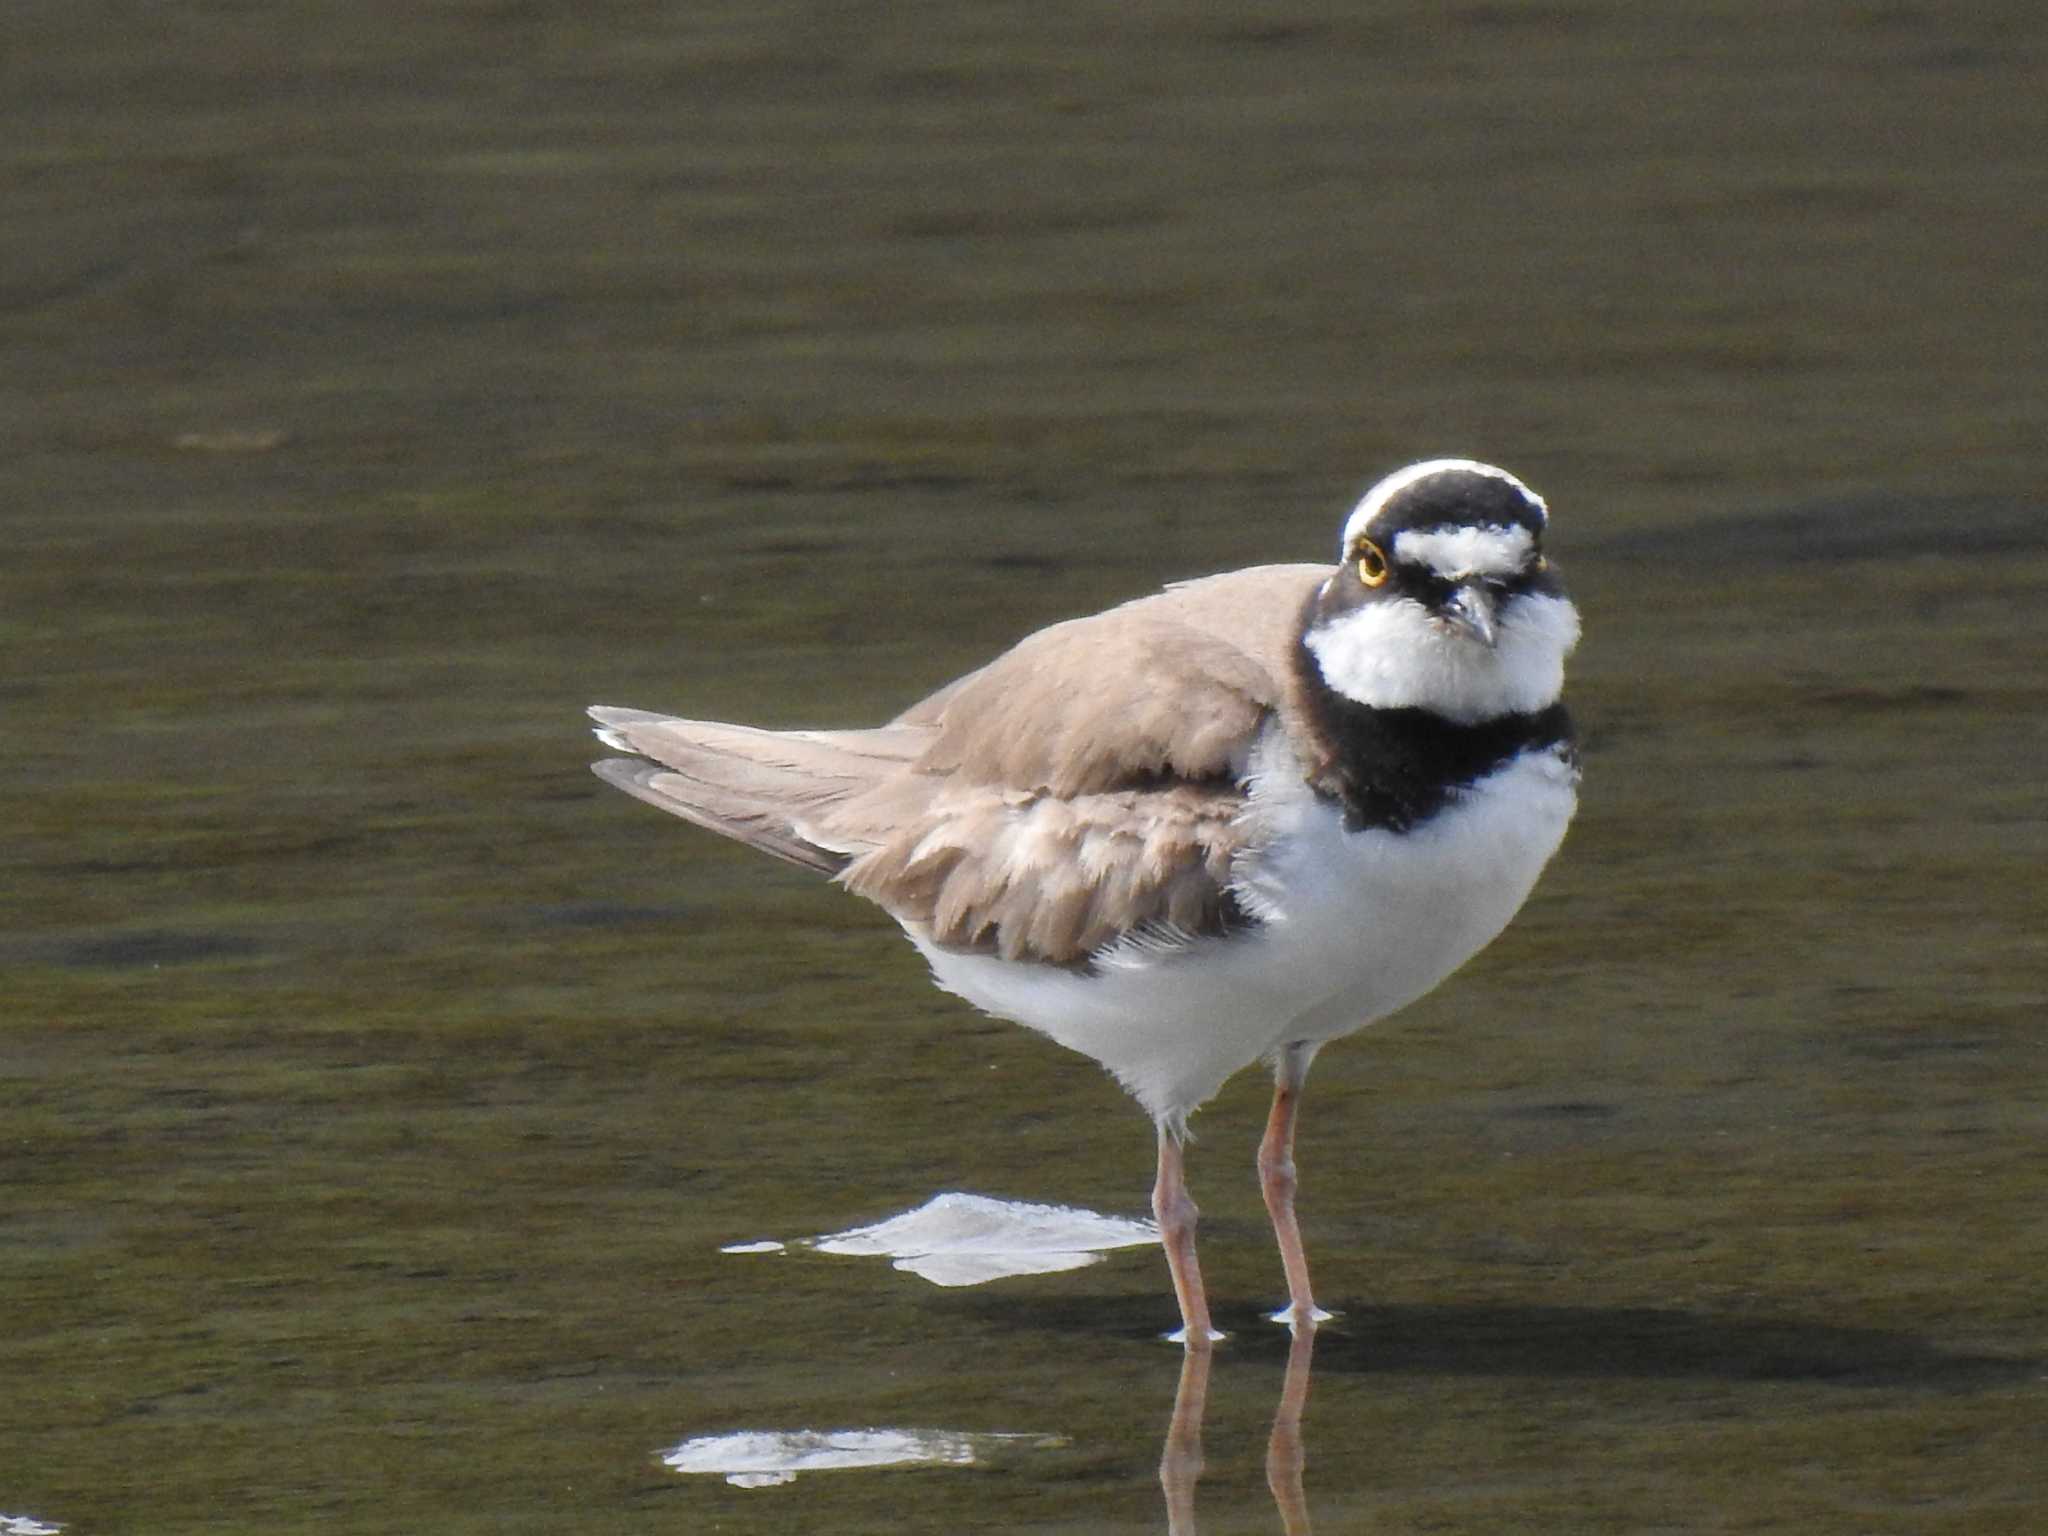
{"left": 592, "top": 565, "right": 1327, "bottom": 965}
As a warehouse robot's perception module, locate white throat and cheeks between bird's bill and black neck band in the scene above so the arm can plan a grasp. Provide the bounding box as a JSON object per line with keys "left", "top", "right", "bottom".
{"left": 1307, "top": 594, "right": 1579, "bottom": 725}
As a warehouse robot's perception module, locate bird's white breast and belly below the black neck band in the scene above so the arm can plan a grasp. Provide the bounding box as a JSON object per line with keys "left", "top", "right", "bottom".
{"left": 911, "top": 743, "right": 1577, "bottom": 1124}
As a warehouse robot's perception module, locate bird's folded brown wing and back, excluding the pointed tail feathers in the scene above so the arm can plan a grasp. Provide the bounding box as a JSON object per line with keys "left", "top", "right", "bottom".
{"left": 819, "top": 565, "right": 1329, "bottom": 965}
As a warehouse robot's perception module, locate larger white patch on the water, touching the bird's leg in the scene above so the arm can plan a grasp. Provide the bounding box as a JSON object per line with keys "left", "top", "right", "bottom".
{"left": 809, "top": 1194, "right": 1159, "bottom": 1286}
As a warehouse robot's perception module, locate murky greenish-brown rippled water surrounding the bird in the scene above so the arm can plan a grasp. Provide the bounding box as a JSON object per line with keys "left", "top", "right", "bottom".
{"left": 0, "top": 0, "right": 2048, "bottom": 1536}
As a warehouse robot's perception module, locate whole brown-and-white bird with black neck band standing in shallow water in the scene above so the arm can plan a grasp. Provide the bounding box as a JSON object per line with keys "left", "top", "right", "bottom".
{"left": 590, "top": 459, "right": 1579, "bottom": 1348}
